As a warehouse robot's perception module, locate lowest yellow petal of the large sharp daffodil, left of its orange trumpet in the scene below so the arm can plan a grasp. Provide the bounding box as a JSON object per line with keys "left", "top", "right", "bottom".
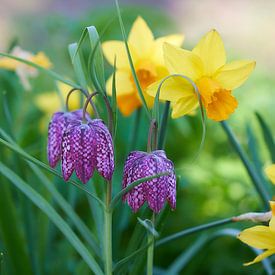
{"left": 172, "top": 94, "right": 199, "bottom": 119}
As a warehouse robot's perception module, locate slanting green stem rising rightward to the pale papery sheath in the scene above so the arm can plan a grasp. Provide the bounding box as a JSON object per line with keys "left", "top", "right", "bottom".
{"left": 156, "top": 218, "right": 235, "bottom": 246}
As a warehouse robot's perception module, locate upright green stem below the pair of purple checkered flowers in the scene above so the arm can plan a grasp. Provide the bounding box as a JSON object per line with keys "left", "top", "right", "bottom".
{"left": 104, "top": 181, "right": 113, "bottom": 275}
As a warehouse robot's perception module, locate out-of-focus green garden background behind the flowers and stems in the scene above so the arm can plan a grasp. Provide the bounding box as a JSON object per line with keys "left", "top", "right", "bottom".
{"left": 0, "top": 0, "right": 275, "bottom": 274}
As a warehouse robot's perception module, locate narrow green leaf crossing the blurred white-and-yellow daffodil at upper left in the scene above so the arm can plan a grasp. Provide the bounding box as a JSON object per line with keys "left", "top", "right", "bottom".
{"left": 0, "top": 53, "right": 81, "bottom": 88}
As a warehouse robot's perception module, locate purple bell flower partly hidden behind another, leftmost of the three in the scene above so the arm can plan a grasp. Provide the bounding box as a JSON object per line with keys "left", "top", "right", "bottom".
{"left": 47, "top": 110, "right": 88, "bottom": 168}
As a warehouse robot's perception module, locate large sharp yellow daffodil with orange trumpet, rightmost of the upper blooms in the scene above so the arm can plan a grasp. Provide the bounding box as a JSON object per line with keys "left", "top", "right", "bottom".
{"left": 147, "top": 30, "right": 255, "bottom": 121}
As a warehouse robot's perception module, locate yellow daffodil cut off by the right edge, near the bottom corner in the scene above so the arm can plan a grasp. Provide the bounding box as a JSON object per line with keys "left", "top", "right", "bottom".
{"left": 238, "top": 201, "right": 275, "bottom": 265}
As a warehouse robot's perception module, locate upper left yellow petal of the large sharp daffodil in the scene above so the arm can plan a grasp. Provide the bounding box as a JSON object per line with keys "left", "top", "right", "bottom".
{"left": 163, "top": 43, "right": 203, "bottom": 81}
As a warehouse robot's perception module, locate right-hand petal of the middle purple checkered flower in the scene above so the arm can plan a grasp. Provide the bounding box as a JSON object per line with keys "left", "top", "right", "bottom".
{"left": 89, "top": 119, "right": 115, "bottom": 180}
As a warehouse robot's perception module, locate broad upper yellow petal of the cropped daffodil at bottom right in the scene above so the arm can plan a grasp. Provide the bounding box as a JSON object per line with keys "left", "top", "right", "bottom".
{"left": 238, "top": 225, "right": 275, "bottom": 249}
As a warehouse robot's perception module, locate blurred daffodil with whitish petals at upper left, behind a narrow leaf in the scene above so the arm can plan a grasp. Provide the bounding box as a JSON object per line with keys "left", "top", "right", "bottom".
{"left": 0, "top": 46, "right": 52, "bottom": 90}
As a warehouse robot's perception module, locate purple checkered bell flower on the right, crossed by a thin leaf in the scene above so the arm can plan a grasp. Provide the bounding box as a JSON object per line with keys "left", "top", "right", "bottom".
{"left": 122, "top": 150, "right": 176, "bottom": 213}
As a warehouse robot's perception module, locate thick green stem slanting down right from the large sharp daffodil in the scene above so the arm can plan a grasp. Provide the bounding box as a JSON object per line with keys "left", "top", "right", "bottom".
{"left": 221, "top": 121, "right": 270, "bottom": 209}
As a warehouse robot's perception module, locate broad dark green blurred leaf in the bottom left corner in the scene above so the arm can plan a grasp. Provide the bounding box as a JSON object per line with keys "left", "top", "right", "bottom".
{"left": 0, "top": 180, "right": 32, "bottom": 275}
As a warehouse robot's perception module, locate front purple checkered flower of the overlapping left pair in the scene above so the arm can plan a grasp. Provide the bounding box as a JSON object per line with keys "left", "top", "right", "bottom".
{"left": 62, "top": 119, "right": 114, "bottom": 183}
